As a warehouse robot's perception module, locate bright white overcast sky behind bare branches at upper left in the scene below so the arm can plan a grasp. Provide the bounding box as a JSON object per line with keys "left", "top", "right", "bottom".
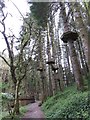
{"left": 0, "top": 0, "right": 29, "bottom": 52}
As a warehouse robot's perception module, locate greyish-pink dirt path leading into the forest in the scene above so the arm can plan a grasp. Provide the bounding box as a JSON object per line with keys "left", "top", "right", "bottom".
{"left": 22, "top": 102, "right": 45, "bottom": 120}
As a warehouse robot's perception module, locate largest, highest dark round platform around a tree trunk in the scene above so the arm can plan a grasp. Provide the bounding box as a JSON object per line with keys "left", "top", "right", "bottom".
{"left": 61, "top": 31, "right": 78, "bottom": 43}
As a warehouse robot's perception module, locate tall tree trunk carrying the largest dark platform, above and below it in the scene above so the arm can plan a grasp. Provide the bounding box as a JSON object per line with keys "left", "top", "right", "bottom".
{"left": 60, "top": 3, "right": 84, "bottom": 90}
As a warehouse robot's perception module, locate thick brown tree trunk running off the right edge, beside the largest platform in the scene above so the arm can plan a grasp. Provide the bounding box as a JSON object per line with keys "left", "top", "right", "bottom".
{"left": 74, "top": 2, "right": 89, "bottom": 68}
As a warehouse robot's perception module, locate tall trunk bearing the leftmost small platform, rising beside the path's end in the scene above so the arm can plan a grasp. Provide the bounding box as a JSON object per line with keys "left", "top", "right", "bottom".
{"left": 38, "top": 30, "right": 47, "bottom": 102}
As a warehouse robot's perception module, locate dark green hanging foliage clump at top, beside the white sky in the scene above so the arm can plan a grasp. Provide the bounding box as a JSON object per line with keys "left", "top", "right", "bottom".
{"left": 30, "top": 2, "right": 50, "bottom": 28}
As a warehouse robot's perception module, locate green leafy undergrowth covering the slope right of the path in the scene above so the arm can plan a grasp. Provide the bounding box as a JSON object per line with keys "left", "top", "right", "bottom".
{"left": 42, "top": 85, "right": 90, "bottom": 120}
